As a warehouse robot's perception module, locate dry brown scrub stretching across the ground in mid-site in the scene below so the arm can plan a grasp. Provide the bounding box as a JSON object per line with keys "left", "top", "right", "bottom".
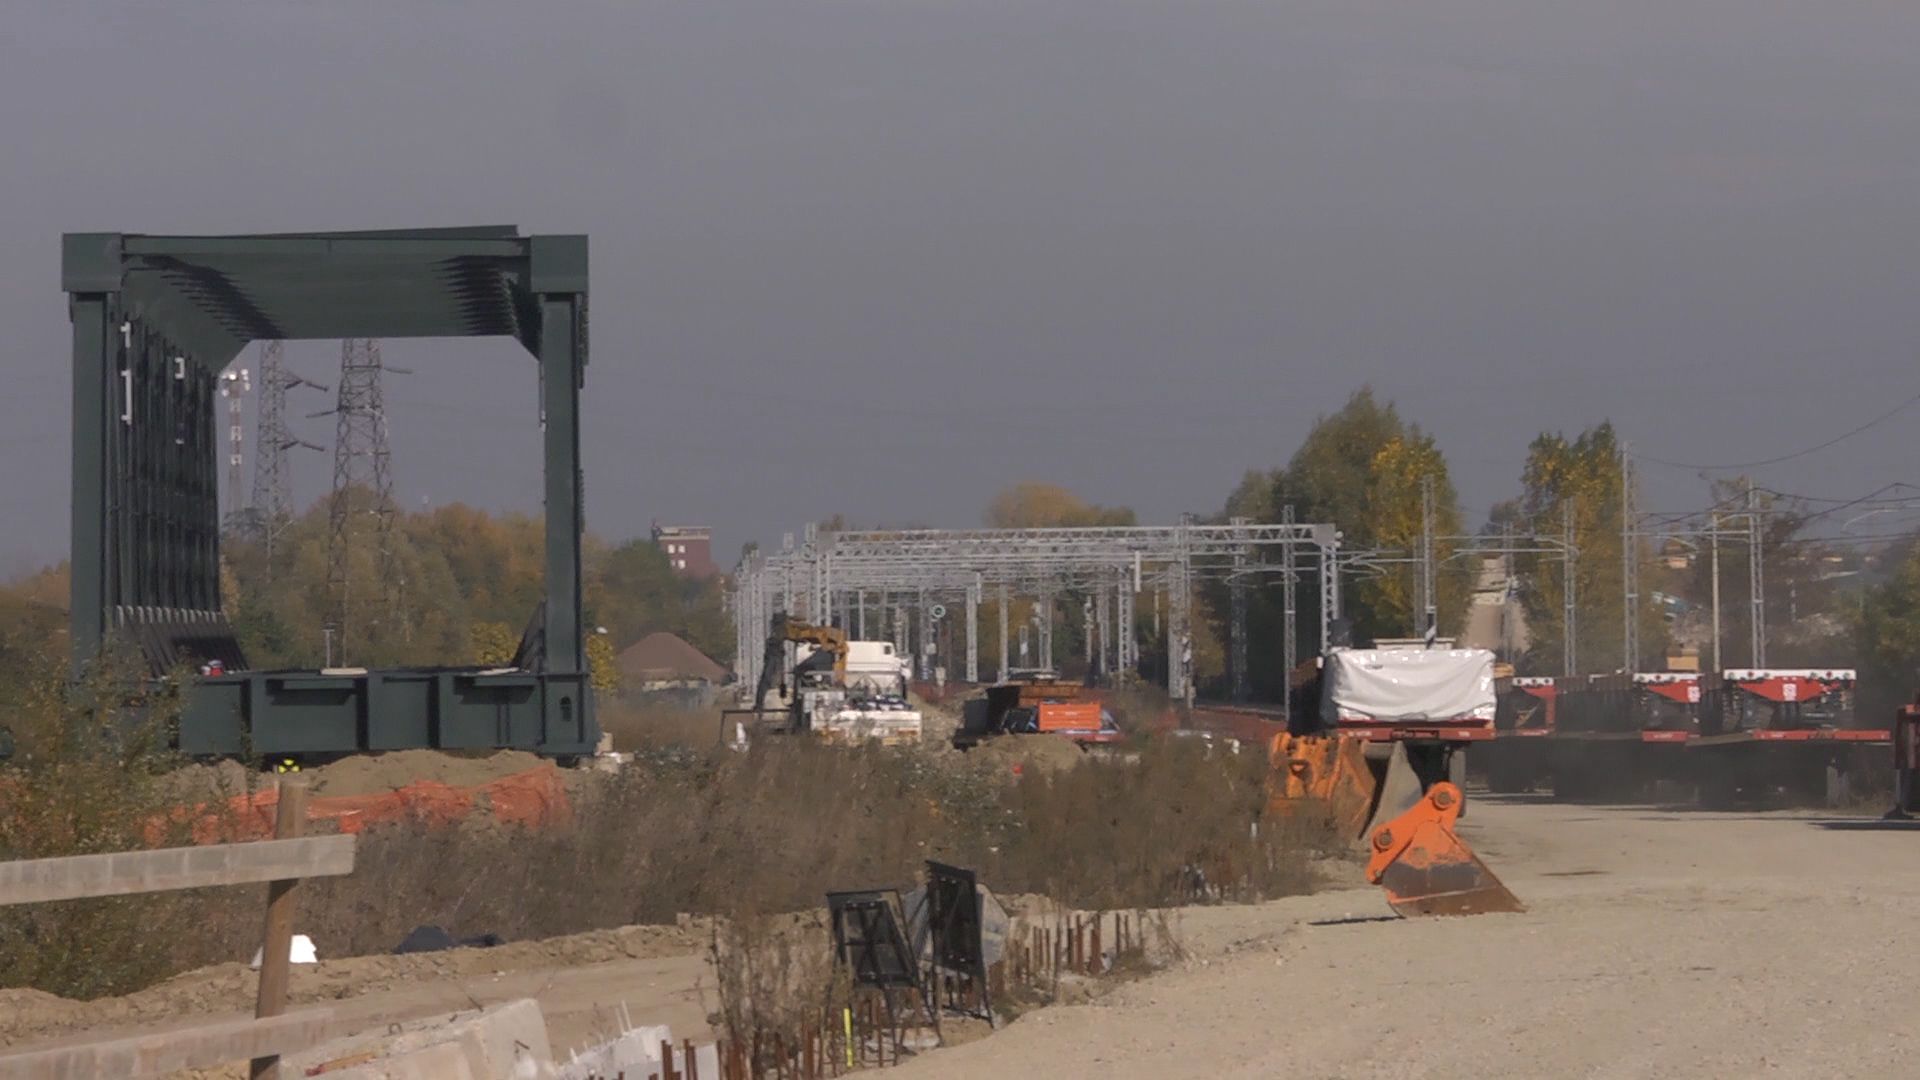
{"left": 0, "top": 711, "right": 1327, "bottom": 1007}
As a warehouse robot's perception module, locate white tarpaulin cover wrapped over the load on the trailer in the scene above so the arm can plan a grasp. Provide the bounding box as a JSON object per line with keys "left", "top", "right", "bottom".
{"left": 1321, "top": 650, "right": 1494, "bottom": 726}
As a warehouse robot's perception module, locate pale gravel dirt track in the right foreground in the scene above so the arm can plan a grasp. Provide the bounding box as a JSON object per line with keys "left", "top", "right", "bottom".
{"left": 899, "top": 798, "right": 1920, "bottom": 1080}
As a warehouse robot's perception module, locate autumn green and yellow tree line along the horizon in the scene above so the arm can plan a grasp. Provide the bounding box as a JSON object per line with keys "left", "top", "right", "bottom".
{"left": 0, "top": 386, "right": 1920, "bottom": 707}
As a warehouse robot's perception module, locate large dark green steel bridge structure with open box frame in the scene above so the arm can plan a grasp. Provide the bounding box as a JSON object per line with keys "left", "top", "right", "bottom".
{"left": 61, "top": 227, "right": 599, "bottom": 757}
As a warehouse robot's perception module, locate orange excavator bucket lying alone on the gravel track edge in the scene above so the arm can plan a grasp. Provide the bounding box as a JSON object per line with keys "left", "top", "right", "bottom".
{"left": 1367, "top": 782, "right": 1526, "bottom": 915}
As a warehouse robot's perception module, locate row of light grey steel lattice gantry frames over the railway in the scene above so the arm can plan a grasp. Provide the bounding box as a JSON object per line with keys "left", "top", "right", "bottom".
{"left": 733, "top": 521, "right": 1340, "bottom": 700}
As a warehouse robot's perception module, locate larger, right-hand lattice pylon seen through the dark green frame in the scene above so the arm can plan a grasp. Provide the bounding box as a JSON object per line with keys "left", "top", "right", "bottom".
{"left": 319, "top": 338, "right": 399, "bottom": 661}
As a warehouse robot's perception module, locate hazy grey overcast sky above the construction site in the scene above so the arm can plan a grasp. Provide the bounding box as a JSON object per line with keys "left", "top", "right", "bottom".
{"left": 0, "top": 0, "right": 1920, "bottom": 571}
